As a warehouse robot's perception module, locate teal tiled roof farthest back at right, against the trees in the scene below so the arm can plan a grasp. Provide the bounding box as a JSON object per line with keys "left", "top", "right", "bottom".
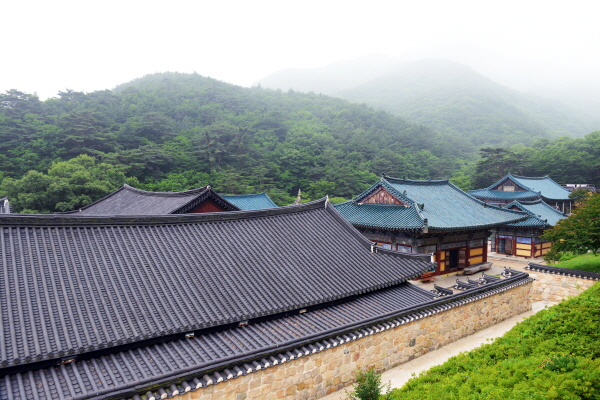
{"left": 469, "top": 174, "right": 570, "bottom": 200}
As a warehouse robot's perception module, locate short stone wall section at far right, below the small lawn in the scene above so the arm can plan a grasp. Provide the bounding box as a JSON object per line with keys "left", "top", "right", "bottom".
{"left": 527, "top": 271, "right": 597, "bottom": 302}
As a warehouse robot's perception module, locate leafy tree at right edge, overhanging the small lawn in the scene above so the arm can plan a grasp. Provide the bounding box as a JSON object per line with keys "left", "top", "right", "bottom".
{"left": 542, "top": 193, "right": 600, "bottom": 261}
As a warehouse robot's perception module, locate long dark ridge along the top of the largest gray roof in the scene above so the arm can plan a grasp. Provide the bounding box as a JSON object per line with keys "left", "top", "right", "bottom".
{"left": 0, "top": 198, "right": 326, "bottom": 226}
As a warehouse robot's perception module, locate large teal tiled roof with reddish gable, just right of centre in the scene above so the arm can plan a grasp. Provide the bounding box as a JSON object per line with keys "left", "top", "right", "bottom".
{"left": 335, "top": 177, "right": 527, "bottom": 230}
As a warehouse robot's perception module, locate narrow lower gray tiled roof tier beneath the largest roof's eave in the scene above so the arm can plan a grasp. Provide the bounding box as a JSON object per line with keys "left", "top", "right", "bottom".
{"left": 0, "top": 283, "right": 434, "bottom": 400}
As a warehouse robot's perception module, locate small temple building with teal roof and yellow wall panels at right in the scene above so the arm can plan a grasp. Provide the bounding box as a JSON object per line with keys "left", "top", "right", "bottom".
{"left": 492, "top": 199, "right": 567, "bottom": 258}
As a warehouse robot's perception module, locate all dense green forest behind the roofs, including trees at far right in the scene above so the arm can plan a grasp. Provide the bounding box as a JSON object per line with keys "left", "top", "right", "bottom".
{"left": 0, "top": 73, "right": 600, "bottom": 212}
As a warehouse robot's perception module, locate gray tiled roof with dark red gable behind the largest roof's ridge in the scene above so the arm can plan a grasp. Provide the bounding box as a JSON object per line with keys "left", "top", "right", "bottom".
{"left": 61, "top": 184, "right": 240, "bottom": 215}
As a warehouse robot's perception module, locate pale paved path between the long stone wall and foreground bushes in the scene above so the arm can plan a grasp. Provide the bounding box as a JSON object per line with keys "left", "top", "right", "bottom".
{"left": 322, "top": 300, "right": 557, "bottom": 400}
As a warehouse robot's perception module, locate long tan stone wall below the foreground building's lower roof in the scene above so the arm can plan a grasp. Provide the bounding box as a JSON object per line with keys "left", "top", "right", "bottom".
{"left": 176, "top": 282, "right": 532, "bottom": 400}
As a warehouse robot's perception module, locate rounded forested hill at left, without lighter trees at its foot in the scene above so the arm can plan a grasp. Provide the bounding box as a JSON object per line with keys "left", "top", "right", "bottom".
{"left": 0, "top": 73, "right": 474, "bottom": 211}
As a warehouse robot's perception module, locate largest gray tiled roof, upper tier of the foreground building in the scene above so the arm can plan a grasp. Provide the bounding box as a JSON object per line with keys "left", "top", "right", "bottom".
{"left": 0, "top": 200, "right": 430, "bottom": 372}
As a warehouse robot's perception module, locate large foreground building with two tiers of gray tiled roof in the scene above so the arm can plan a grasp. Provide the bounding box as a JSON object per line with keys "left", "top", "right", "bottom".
{"left": 0, "top": 199, "right": 442, "bottom": 400}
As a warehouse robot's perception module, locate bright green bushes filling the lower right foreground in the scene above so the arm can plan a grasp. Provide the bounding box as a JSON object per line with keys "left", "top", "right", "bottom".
{"left": 392, "top": 284, "right": 600, "bottom": 400}
